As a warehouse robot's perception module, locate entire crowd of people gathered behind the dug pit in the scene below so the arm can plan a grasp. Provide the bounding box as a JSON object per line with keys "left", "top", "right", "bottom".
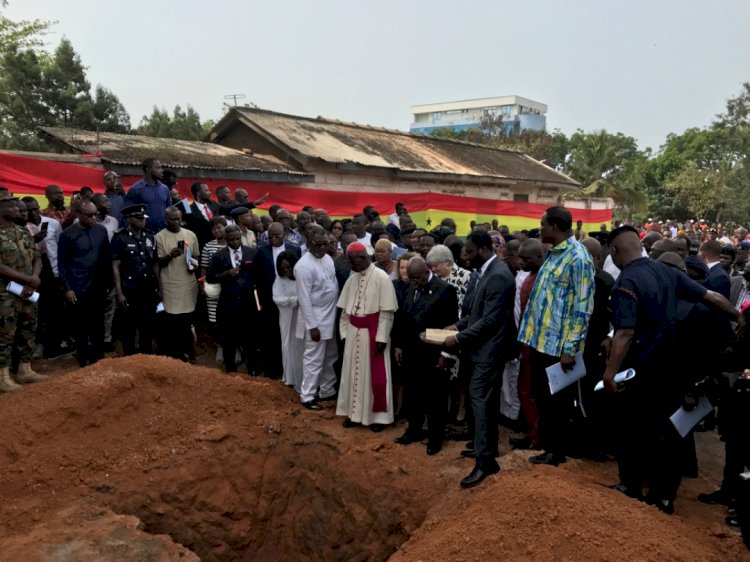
{"left": 0, "top": 158, "right": 750, "bottom": 521}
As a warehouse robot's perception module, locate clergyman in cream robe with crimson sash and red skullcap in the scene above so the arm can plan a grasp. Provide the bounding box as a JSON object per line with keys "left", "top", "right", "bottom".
{"left": 336, "top": 242, "right": 402, "bottom": 431}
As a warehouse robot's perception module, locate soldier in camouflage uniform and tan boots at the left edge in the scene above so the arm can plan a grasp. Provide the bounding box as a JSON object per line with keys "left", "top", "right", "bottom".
{"left": 0, "top": 192, "right": 47, "bottom": 392}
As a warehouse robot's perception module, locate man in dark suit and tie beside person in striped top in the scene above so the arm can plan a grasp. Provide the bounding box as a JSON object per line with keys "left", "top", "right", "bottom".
{"left": 206, "top": 225, "right": 260, "bottom": 375}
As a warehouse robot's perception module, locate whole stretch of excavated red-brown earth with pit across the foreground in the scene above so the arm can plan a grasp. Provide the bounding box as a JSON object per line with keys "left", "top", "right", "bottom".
{"left": 0, "top": 356, "right": 746, "bottom": 562}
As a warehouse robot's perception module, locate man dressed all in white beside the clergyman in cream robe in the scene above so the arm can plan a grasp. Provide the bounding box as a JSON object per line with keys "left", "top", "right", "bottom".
{"left": 294, "top": 225, "right": 339, "bottom": 410}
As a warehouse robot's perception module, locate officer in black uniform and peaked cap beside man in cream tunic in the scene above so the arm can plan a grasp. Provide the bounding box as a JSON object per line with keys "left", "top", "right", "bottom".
{"left": 111, "top": 205, "right": 159, "bottom": 355}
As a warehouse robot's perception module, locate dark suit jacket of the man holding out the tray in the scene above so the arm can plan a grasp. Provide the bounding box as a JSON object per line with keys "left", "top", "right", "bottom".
{"left": 456, "top": 258, "right": 517, "bottom": 363}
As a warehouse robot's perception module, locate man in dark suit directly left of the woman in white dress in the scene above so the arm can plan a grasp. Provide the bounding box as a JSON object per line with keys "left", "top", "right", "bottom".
{"left": 256, "top": 222, "right": 300, "bottom": 378}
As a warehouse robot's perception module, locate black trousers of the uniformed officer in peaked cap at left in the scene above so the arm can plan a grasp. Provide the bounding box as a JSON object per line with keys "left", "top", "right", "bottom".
{"left": 118, "top": 287, "right": 157, "bottom": 355}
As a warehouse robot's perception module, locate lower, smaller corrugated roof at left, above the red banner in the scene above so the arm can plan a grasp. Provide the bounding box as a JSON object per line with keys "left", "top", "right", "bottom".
{"left": 39, "top": 127, "right": 307, "bottom": 175}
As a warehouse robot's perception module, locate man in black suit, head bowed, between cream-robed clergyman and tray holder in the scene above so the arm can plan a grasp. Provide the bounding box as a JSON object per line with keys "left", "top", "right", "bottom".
{"left": 391, "top": 257, "right": 458, "bottom": 455}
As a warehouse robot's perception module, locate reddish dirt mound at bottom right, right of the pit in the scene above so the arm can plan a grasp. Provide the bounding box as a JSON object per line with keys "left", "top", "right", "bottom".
{"left": 391, "top": 466, "right": 750, "bottom": 562}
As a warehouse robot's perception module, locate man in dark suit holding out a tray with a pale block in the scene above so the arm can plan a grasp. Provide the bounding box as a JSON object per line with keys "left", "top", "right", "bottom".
{"left": 445, "top": 231, "right": 517, "bottom": 488}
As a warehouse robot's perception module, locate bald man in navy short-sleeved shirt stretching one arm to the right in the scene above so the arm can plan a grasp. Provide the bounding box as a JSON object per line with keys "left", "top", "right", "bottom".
{"left": 603, "top": 226, "right": 745, "bottom": 513}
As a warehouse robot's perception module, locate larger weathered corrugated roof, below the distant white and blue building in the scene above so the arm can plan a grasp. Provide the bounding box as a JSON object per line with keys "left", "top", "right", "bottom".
{"left": 222, "top": 107, "right": 578, "bottom": 188}
